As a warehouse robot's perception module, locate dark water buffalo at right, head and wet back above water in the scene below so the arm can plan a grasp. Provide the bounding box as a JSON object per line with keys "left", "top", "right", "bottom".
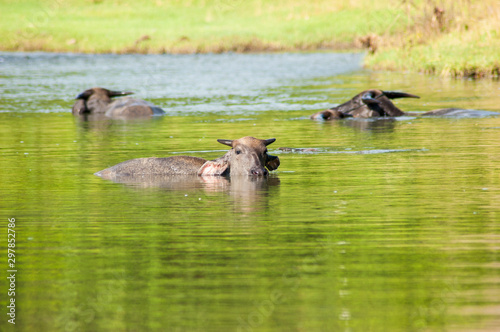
{"left": 311, "top": 89, "right": 495, "bottom": 120}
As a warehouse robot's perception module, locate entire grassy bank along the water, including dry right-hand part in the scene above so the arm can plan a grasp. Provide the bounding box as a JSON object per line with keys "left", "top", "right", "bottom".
{"left": 0, "top": 0, "right": 500, "bottom": 76}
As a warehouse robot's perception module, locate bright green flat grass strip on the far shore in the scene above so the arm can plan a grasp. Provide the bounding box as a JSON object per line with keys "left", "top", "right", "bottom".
{"left": 0, "top": 0, "right": 404, "bottom": 53}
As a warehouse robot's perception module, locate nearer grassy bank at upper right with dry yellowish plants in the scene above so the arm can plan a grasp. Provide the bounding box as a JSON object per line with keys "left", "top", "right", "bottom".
{"left": 366, "top": 0, "right": 500, "bottom": 78}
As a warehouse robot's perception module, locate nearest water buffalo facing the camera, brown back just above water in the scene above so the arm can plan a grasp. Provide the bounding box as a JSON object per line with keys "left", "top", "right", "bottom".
{"left": 95, "top": 137, "right": 280, "bottom": 180}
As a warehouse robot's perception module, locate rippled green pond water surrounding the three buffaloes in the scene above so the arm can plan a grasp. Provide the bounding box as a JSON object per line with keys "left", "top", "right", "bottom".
{"left": 0, "top": 53, "right": 500, "bottom": 332}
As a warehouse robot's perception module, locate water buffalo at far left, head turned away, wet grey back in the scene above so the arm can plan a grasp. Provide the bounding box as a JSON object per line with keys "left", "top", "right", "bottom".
{"left": 72, "top": 87, "right": 165, "bottom": 117}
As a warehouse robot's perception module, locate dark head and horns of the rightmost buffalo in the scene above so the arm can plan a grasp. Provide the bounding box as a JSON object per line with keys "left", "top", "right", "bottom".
{"left": 311, "top": 89, "right": 420, "bottom": 120}
